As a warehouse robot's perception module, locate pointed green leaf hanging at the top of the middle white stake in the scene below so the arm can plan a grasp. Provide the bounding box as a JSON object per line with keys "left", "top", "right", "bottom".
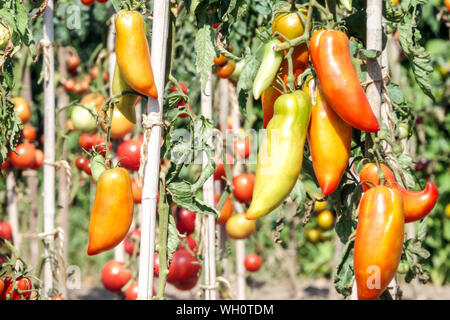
{"left": 194, "top": 24, "right": 216, "bottom": 91}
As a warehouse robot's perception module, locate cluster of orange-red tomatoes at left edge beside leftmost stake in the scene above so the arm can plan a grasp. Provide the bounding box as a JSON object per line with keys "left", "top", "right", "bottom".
{"left": 1, "top": 97, "right": 44, "bottom": 171}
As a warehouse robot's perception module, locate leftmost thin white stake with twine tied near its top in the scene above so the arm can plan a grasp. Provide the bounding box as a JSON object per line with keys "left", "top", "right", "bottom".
{"left": 42, "top": 0, "right": 55, "bottom": 296}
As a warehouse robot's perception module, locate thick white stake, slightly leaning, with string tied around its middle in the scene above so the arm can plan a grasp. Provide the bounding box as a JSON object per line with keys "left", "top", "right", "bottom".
{"left": 138, "top": 1, "right": 169, "bottom": 300}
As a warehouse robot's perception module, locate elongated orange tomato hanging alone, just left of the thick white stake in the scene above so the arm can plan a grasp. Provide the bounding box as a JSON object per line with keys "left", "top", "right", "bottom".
{"left": 88, "top": 168, "right": 134, "bottom": 255}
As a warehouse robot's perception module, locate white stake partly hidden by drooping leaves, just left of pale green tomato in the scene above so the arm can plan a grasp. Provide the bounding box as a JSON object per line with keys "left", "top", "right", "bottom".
{"left": 201, "top": 72, "right": 217, "bottom": 300}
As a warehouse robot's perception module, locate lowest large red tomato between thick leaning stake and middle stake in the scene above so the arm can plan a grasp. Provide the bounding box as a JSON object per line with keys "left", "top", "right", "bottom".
{"left": 167, "top": 249, "right": 201, "bottom": 290}
